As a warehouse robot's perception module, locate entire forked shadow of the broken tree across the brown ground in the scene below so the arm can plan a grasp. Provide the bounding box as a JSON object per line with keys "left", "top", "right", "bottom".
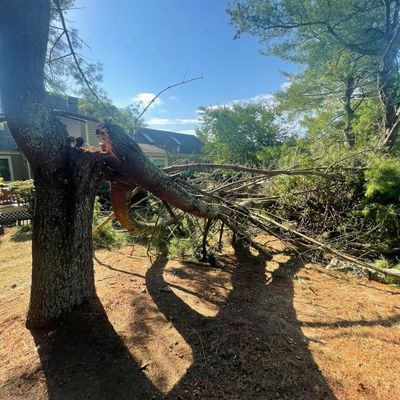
{"left": 32, "top": 241, "right": 344, "bottom": 400}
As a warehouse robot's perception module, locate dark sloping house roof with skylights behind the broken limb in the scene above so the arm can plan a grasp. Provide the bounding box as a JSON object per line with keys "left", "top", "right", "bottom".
{"left": 136, "top": 128, "right": 204, "bottom": 154}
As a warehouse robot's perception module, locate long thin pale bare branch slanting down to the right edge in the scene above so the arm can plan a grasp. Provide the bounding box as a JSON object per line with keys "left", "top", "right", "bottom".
{"left": 257, "top": 214, "right": 400, "bottom": 278}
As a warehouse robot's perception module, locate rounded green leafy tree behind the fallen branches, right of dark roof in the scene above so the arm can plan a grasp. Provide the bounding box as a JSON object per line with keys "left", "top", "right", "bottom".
{"left": 197, "top": 103, "right": 284, "bottom": 165}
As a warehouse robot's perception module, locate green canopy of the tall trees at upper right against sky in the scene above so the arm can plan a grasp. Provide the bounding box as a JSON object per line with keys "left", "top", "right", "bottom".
{"left": 228, "top": 0, "right": 400, "bottom": 149}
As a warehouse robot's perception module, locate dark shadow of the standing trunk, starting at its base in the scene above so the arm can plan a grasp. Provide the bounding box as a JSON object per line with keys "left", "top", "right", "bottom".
{"left": 32, "top": 298, "right": 160, "bottom": 400}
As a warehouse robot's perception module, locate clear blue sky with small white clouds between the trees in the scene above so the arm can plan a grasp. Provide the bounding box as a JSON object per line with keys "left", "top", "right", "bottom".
{"left": 67, "top": 0, "right": 295, "bottom": 133}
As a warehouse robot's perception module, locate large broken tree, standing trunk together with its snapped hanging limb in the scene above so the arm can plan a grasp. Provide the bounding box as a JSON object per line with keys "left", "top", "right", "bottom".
{"left": 0, "top": 0, "right": 396, "bottom": 328}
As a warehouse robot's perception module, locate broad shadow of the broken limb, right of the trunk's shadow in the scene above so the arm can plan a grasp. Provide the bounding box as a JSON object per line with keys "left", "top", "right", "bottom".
{"left": 146, "top": 242, "right": 336, "bottom": 400}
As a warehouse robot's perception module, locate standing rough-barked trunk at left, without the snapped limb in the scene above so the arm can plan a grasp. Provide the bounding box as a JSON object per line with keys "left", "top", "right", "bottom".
{"left": 0, "top": 0, "right": 103, "bottom": 328}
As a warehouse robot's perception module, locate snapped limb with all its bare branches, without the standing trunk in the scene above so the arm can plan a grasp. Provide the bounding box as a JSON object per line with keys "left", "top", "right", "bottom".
{"left": 99, "top": 123, "right": 400, "bottom": 278}
